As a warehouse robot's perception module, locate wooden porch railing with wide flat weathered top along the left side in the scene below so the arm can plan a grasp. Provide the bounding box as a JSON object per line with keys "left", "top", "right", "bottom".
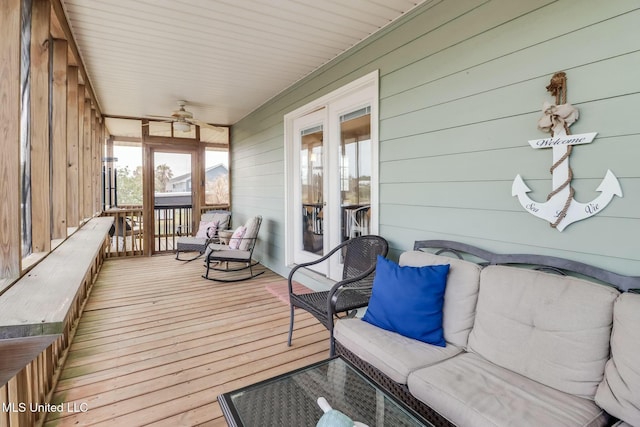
{"left": 0, "top": 218, "right": 113, "bottom": 427}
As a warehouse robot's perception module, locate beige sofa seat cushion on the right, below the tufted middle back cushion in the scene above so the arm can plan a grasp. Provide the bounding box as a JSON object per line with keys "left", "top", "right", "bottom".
{"left": 408, "top": 353, "right": 608, "bottom": 427}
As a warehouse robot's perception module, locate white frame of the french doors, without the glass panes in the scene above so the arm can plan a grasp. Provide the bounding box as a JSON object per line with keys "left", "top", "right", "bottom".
{"left": 284, "top": 70, "right": 379, "bottom": 275}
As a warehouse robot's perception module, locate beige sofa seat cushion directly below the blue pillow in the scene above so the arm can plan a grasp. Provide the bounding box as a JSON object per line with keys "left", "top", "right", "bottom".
{"left": 333, "top": 319, "right": 462, "bottom": 384}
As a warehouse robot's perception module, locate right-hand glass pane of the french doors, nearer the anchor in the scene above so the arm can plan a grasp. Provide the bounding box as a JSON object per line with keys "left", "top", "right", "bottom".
{"left": 340, "top": 107, "right": 372, "bottom": 241}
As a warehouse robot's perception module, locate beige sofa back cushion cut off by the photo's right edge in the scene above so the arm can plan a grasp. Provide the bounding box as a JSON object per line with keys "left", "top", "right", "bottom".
{"left": 596, "top": 293, "right": 640, "bottom": 426}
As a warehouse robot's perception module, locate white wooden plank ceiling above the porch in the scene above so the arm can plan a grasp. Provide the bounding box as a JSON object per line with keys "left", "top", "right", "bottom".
{"left": 61, "top": 0, "right": 425, "bottom": 135}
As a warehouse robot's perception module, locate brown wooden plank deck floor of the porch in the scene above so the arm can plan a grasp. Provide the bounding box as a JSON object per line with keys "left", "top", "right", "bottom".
{"left": 45, "top": 255, "right": 329, "bottom": 426}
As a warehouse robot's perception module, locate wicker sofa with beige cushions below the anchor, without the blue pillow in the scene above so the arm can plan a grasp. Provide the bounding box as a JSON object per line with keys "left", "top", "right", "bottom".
{"left": 335, "top": 241, "right": 640, "bottom": 427}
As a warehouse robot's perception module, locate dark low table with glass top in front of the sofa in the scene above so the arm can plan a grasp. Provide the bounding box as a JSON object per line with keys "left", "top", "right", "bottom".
{"left": 218, "top": 357, "right": 432, "bottom": 427}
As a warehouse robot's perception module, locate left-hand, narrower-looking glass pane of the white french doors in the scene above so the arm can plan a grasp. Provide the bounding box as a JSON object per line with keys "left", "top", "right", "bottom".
{"left": 300, "top": 126, "right": 324, "bottom": 255}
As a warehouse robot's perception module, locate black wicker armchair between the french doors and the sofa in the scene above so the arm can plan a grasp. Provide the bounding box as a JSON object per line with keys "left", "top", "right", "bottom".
{"left": 287, "top": 235, "right": 389, "bottom": 356}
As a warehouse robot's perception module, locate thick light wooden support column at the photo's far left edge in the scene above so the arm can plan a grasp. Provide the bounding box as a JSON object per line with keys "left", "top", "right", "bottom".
{"left": 0, "top": 0, "right": 21, "bottom": 289}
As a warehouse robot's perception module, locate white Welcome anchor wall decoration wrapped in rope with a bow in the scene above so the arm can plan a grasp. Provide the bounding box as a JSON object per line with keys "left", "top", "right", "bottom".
{"left": 511, "top": 73, "right": 622, "bottom": 231}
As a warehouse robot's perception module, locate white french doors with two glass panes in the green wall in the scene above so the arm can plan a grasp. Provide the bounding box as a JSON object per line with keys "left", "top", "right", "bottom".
{"left": 285, "top": 73, "right": 378, "bottom": 280}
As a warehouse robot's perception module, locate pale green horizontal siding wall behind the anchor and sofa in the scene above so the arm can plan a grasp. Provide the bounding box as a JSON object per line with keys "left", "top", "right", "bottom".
{"left": 231, "top": 0, "right": 640, "bottom": 274}
